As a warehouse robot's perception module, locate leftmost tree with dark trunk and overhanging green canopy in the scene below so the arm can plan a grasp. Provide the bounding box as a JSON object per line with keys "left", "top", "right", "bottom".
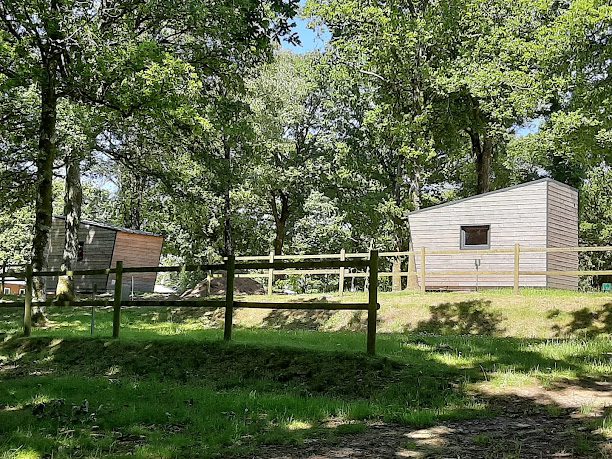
{"left": 0, "top": 0, "right": 296, "bottom": 302}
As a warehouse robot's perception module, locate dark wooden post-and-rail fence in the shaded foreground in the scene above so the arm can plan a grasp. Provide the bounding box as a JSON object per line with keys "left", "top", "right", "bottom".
{"left": 0, "top": 250, "right": 380, "bottom": 355}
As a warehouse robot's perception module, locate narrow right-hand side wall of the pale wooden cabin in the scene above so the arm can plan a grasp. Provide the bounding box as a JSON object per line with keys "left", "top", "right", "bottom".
{"left": 547, "top": 181, "right": 578, "bottom": 290}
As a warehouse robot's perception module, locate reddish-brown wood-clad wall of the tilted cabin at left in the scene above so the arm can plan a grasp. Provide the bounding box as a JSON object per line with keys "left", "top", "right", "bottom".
{"left": 107, "top": 232, "right": 164, "bottom": 293}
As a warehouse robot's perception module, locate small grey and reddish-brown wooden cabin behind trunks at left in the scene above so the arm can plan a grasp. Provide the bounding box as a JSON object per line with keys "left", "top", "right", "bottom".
{"left": 47, "top": 217, "right": 164, "bottom": 292}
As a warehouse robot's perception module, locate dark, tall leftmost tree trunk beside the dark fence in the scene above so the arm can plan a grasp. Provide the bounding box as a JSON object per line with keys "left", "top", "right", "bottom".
{"left": 32, "top": 66, "right": 57, "bottom": 324}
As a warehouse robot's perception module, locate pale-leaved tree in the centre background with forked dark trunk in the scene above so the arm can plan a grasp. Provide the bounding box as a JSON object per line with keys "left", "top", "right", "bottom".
{"left": 247, "top": 51, "right": 325, "bottom": 255}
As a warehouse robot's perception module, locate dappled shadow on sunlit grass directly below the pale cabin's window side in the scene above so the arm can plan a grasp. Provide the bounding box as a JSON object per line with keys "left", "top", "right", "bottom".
{"left": 414, "top": 300, "right": 503, "bottom": 336}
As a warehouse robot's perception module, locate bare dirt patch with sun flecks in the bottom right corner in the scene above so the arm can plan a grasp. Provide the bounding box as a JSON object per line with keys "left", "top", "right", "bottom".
{"left": 244, "top": 394, "right": 612, "bottom": 459}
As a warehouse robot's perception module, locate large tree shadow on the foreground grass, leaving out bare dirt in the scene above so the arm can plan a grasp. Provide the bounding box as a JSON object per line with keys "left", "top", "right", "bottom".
{"left": 0, "top": 332, "right": 608, "bottom": 457}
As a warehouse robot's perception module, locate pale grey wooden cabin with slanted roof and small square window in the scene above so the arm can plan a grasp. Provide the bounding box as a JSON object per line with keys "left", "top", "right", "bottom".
{"left": 409, "top": 178, "right": 578, "bottom": 290}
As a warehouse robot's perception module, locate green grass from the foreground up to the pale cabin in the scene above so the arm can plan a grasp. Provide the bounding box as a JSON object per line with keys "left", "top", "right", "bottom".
{"left": 0, "top": 291, "right": 612, "bottom": 458}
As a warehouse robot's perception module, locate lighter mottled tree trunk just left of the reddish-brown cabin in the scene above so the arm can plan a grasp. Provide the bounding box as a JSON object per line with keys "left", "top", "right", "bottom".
{"left": 55, "top": 155, "right": 83, "bottom": 301}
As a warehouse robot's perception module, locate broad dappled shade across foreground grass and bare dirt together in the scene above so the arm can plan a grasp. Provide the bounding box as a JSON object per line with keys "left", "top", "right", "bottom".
{"left": 0, "top": 331, "right": 605, "bottom": 458}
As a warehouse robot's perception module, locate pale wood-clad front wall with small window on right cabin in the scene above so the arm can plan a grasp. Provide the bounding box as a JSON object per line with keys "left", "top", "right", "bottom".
{"left": 409, "top": 180, "right": 548, "bottom": 289}
